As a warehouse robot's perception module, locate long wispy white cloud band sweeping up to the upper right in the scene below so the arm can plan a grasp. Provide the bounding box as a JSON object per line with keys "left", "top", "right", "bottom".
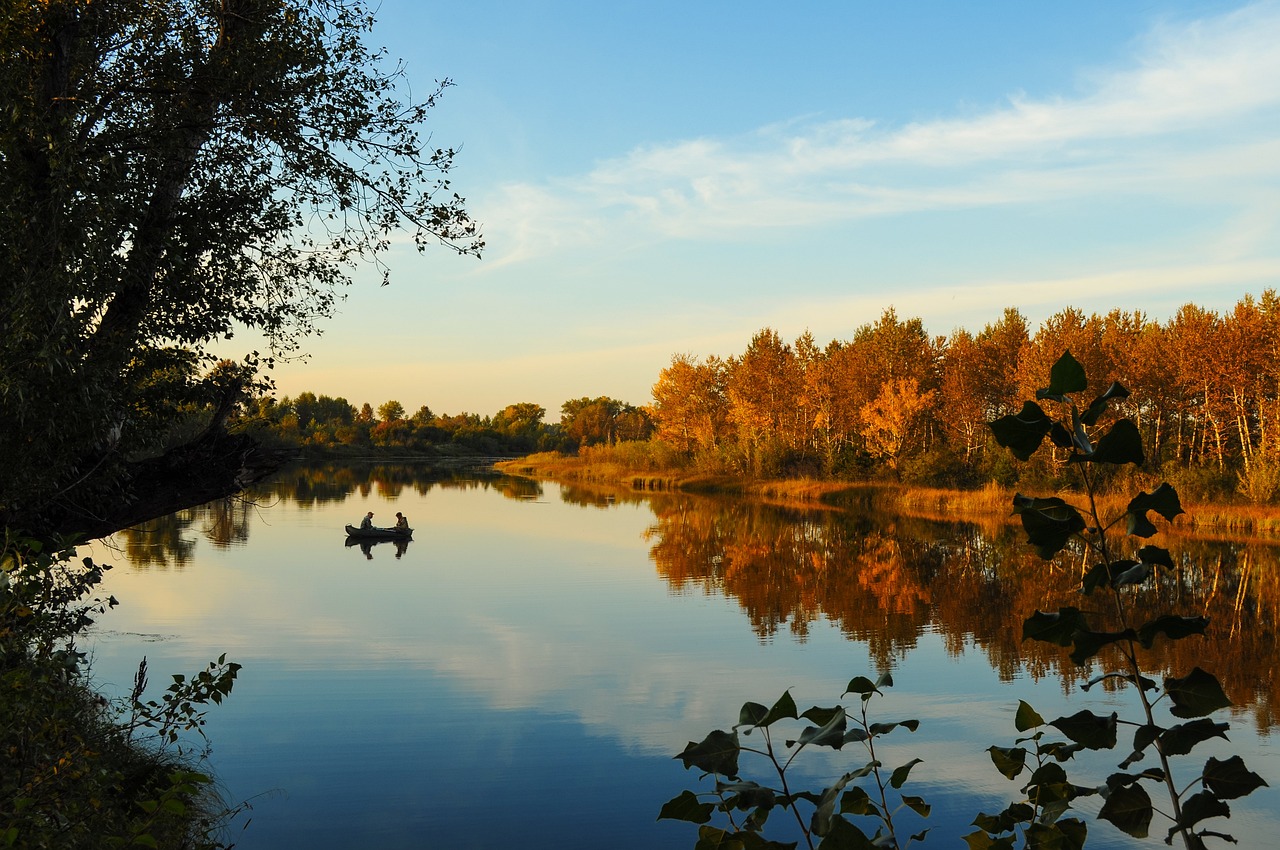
{"left": 480, "top": 3, "right": 1280, "bottom": 268}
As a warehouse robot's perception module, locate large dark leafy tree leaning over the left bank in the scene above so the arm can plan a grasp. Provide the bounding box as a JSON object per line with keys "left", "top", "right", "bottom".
{"left": 0, "top": 0, "right": 483, "bottom": 535}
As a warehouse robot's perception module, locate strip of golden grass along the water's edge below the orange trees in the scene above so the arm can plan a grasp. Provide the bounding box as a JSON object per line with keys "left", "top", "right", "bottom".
{"left": 494, "top": 452, "right": 1280, "bottom": 543}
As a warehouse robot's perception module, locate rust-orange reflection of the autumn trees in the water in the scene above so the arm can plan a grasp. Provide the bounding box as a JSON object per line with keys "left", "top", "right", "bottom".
{"left": 649, "top": 498, "right": 1280, "bottom": 728}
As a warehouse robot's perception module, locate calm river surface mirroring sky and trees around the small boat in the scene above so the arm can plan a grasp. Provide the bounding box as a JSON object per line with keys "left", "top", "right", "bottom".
{"left": 85, "top": 467, "right": 1280, "bottom": 850}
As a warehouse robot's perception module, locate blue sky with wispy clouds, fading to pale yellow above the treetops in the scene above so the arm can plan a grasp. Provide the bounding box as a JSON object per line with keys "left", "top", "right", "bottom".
{"left": 257, "top": 0, "right": 1280, "bottom": 421}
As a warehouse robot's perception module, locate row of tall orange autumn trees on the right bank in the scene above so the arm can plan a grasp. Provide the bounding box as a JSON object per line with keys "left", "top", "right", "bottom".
{"left": 649, "top": 289, "right": 1280, "bottom": 501}
